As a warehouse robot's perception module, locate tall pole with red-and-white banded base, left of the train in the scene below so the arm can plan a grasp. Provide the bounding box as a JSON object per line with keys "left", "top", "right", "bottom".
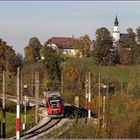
{"left": 16, "top": 67, "right": 20, "bottom": 139}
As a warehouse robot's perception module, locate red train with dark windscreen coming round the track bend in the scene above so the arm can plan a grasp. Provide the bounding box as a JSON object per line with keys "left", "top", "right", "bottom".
{"left": 45, "top": 91, "right": 64, "bottom": 118}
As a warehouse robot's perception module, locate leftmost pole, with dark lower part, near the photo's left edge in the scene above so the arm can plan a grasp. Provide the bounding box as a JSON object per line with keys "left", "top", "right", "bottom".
{"left": 2, "top": 71, "right": 6, "bottom": 138}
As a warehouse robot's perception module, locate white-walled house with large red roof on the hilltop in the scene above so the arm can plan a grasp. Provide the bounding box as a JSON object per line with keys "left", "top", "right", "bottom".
{"left": 47, "top": 37, "right": 79, "bottom": 56}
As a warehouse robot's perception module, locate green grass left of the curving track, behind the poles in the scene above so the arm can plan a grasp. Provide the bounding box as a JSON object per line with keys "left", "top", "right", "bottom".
{"left": 0, "top": 101, "right": 35, "bottom": 138}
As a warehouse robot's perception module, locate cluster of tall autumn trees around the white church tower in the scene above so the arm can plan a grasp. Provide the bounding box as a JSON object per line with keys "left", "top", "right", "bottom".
{"left": 92, "top": 27, "right": 140, "bottom": 65}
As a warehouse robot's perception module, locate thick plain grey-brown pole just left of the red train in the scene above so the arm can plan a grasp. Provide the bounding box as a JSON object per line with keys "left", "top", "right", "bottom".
{"left": 35, "top": 71, "right": 39, "bottom": 124}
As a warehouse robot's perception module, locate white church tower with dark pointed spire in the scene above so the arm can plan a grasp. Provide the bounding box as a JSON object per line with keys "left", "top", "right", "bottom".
{"left": 113, "top": 15, "right": 120, "bottom": 43}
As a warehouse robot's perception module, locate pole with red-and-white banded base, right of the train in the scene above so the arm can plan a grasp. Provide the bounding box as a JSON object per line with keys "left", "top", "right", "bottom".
{"left": 88, "top": 72, "right": 91, "bottom": 119}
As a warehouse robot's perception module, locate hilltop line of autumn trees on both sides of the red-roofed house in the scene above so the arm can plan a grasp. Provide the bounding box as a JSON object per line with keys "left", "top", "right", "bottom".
{"left": 0, "top": 27, "right": 140, "bottom": 79}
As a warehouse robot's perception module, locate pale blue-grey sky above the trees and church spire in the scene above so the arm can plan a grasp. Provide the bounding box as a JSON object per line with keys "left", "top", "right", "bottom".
{"left": 0, "top": 1, "right": 140, "bottom": 54}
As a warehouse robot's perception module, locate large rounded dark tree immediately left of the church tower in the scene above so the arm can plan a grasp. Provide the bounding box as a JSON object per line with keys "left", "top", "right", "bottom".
{"left": 94, "top": 27, "right": 113, "bottom": 65}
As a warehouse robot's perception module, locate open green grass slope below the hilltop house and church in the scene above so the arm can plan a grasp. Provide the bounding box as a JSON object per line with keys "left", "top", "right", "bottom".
{"left": 65, "top": 58, "right": 140, "bottom": 83}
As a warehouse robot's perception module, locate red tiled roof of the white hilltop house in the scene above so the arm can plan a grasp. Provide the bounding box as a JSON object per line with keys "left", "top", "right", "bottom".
{"left": 49, "top": 37, "right": 78, "bottom": 49}
